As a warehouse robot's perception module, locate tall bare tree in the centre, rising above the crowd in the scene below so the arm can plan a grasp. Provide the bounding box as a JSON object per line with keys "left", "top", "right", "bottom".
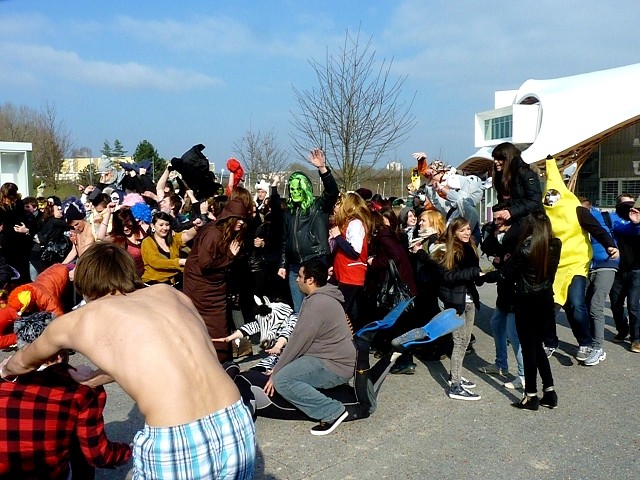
{"left": 292, "top": 31, "right": 416, "bottom": 189}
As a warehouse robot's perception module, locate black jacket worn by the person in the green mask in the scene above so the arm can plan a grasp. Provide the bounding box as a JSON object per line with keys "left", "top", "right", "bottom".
{"left": 279, "top": 169, "right": 339, "bottom": 268}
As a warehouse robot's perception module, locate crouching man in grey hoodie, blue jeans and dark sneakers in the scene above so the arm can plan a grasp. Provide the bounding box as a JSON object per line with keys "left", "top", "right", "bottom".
{"left": 264, "top": 258, "right": 356, "bottom": 435}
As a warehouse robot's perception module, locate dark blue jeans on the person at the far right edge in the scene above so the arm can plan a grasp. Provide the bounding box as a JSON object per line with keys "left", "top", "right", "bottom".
{"left": 611, "top": 270, "right": 640, "bottom": 341}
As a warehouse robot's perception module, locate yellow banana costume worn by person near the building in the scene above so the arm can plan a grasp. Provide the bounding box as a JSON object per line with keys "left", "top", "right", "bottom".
{"left": 542, "top": 158, "right": 592, "bottom": 305}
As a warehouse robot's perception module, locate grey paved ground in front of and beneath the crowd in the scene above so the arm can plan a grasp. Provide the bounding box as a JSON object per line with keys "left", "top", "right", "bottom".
{"left": 0, "top": 280, "right": 640, "bottom": 480}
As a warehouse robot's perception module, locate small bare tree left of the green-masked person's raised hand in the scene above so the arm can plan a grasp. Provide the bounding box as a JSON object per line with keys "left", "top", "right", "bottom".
{"left": 234, "top": 128, "right": 289, "bottom": 188}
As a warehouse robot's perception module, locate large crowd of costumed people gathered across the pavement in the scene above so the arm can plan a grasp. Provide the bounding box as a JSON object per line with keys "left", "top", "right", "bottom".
{"left": 0, "top": 143, "right": 640, "bottom": 478}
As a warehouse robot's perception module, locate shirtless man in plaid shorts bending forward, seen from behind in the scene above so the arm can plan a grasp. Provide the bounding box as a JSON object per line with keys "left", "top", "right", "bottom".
{"left": 0, "top": 243, "right": 255, "bottom": 479}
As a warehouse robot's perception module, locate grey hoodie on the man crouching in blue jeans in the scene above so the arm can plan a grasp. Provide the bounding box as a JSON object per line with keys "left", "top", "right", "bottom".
{"left": 273, "top": 284, "right": 356, "bottom": 378}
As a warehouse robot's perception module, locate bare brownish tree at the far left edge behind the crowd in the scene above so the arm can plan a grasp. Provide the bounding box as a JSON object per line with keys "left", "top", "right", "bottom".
{"left": 0, "top": 102, "right": 72, "bottom": 190}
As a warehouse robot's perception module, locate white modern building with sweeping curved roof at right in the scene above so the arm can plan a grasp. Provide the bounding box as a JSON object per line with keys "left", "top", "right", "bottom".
{"left": 460, "top": 64, "right": 640, "bottom": 207}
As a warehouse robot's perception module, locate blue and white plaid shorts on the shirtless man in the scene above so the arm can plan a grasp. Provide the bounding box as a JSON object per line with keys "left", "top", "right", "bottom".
{"left": 133, "top": 400, "right": 256, "bottom": 480}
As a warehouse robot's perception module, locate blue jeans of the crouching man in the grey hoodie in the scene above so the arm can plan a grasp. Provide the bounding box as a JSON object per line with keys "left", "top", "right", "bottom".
{"left": 273, "top": 355, "right": 349, "bottom": 422}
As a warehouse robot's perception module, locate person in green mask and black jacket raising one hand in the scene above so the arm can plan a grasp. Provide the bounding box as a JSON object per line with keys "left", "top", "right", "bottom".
{"left": 278, "top": 148, "right": 339, "bottom": 312}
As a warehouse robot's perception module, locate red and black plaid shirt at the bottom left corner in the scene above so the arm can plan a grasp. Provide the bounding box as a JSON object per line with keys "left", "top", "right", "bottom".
{"left": 0, "top": 364, "right": 131, "bottom": 479}
